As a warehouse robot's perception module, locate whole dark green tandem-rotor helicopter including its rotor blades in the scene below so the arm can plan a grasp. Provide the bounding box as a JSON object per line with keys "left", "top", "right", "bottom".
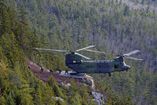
{"left": 36, "top": 45, "right": 143, "bottom": 76}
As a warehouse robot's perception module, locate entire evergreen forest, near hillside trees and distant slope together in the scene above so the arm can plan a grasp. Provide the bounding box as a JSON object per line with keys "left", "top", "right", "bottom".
{"left": 0, "top": 0, "right": 157, "bottom": 105}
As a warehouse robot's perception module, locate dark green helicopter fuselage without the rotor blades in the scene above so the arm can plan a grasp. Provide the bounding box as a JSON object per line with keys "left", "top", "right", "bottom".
{"left": 66, "top": 54, "right": 130, "bottom": 73}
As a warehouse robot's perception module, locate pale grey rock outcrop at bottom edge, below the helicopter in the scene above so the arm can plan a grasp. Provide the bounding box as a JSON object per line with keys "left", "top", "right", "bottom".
{"left": 92, "top": 91, "right": 106, "bottom": 105}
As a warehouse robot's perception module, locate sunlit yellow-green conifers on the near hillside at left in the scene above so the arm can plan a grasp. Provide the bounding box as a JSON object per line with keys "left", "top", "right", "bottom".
{"left": 0, "top": 1, "right": 100, "bottom": 105}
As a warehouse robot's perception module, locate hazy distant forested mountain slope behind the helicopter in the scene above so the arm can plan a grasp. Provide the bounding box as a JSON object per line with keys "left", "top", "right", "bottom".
{"left": 6, "top": 0, "right": 157, "bottom": 105}
